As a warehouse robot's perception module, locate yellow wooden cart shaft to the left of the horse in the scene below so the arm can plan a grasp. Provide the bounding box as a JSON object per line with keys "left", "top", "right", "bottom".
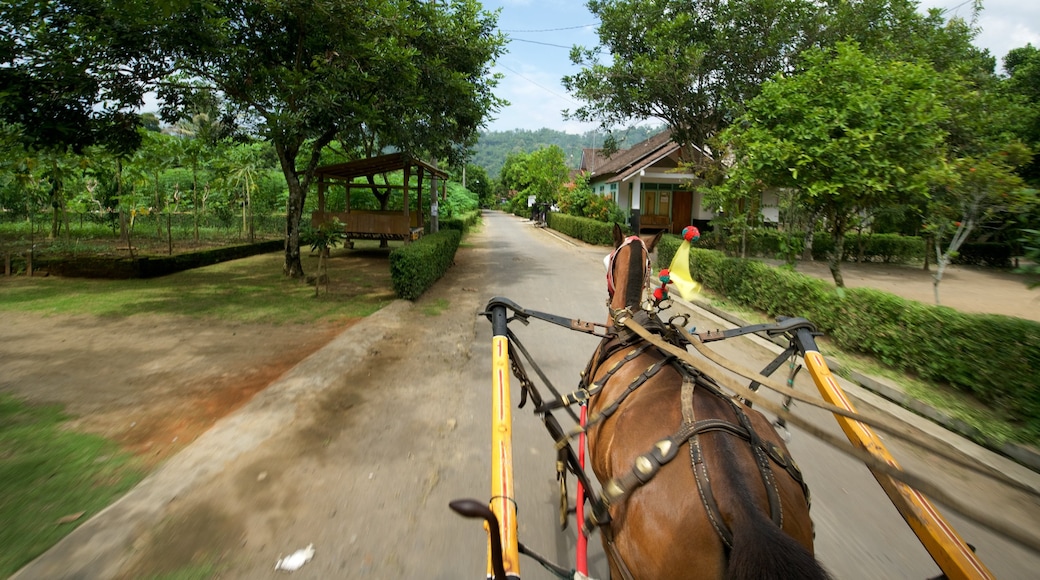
{"left": 488, "top": 336, "right": 520, "bottom": 578}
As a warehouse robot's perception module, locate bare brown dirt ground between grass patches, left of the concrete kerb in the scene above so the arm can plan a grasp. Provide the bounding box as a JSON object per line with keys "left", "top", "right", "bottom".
{"left": 0, "top": 313, "right": 350, "bottom": 465}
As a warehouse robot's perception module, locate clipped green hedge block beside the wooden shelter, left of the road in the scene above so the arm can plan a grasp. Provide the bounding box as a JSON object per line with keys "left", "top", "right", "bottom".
{"left": 390, "top": 230, "right": 462, "bottom": 300}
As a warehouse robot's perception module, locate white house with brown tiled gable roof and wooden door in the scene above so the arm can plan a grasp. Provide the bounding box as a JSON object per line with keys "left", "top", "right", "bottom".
{"left": 579, "top": 131, "right": 779, "bottom": 234}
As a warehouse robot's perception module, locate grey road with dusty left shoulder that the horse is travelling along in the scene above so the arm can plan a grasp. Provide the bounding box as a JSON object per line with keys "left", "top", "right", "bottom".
{"left": 18, "top": 213, "right": 1040, "bottom": 579}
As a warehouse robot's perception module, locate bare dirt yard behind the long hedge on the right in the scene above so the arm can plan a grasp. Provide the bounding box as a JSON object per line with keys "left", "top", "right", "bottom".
{"left": 765, "top": 260, "right": 1040, "bottom": 322}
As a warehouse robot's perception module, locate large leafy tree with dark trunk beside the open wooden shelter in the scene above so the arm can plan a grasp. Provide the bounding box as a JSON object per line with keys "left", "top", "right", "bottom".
{"left": 167, "top": 0, "right": 503, "bottom": 278}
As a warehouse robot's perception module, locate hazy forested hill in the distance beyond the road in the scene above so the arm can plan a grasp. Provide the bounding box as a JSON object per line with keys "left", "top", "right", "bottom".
{"left": 471, "top": 126, "right": 664, "bottom": 178}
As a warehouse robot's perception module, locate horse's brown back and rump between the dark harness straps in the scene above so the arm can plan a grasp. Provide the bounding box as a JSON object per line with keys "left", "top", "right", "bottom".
{"left": 589, "top": 347, "right": 812, "bottom": 579}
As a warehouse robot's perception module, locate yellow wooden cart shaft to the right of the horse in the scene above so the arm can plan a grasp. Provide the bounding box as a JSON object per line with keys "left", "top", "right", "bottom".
{"left": 805, "top": 350, "right": 993, "bottom": 580}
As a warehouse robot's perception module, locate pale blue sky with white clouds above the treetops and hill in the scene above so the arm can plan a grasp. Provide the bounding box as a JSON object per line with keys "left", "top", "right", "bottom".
{"left": 483, "top": 0, "right": 1040, "bottom": 133}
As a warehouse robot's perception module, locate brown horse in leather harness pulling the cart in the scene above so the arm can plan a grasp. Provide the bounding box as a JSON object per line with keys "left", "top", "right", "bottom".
{"left": 587, "top": 227, "right": 827, "bottom": 580}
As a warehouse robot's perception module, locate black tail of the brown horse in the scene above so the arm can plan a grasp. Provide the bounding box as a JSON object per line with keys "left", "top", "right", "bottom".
{"left": 726, "top": 505, "right": 830, "bottom": 580}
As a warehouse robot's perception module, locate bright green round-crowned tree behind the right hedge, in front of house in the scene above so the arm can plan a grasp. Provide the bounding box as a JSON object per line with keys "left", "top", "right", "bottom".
{"left": 716, "top": 43, "right": 947, "bottom": 287}
